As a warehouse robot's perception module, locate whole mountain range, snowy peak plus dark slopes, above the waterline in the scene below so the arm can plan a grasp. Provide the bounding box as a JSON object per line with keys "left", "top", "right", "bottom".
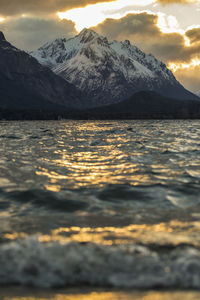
{"left": 0, "top": 30, "right": 200, "bottom": 120}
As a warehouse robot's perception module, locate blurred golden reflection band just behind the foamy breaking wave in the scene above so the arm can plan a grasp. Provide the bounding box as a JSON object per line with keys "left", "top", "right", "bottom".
{"left": 4, "top": 221, "right": 200, "bottom": 247}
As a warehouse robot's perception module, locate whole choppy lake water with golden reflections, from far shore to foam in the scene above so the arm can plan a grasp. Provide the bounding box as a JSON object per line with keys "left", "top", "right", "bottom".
{"left": 0, "top": 121, "right": 200, "bottom": 290}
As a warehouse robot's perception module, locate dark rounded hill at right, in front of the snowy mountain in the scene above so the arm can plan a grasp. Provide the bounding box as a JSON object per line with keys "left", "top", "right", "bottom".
{"left": 72, "top": 91, "right": 200, "bottom": 119}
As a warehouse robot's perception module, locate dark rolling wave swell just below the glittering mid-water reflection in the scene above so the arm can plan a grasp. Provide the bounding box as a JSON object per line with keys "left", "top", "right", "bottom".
{"left": 0, "top": 183, "right": 199, "bottom": 215}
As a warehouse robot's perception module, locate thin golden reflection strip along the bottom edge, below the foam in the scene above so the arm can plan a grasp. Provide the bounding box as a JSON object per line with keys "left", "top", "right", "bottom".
{"left": 3, "top": 288, "right": 200, "bottom": 300}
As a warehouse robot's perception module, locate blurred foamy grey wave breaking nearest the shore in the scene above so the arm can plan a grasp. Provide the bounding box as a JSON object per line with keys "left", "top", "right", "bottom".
{"left": 0, "top": 236, "right": 200, "bottom": 289}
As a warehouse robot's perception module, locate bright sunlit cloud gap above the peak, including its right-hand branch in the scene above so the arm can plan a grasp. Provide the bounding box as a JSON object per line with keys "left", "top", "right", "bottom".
{"left": 58, "top": 0, "right": 196, "bottom": 47}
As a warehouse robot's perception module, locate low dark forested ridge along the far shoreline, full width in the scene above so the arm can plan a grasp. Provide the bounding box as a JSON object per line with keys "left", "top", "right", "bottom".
{"left": 0, "top": 91, "right": 200, "bottom": 120}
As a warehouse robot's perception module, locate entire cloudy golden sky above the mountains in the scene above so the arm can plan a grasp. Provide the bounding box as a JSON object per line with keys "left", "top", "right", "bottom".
{"left": 0, "top": 0, "right": 200, "bottom": 92}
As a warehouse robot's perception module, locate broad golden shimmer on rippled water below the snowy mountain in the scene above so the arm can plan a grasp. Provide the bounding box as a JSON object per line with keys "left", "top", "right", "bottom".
{"left": 31, "top": 122, "right": 192, "bottom": 191}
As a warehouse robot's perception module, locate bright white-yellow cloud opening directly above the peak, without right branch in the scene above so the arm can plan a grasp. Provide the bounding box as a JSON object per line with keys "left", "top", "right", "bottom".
{"left": 58, "top": 0, "right": 156, "bottom": 31}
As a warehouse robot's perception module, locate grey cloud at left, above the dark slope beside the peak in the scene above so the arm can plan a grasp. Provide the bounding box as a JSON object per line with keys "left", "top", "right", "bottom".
{"left": 0, "top": 18, "right": 76, "bottom": 50}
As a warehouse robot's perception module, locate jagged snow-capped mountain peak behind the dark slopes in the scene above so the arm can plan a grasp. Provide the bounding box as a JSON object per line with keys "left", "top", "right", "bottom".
{"left": 31, "top": 29, "right": 198, "bottom": 106}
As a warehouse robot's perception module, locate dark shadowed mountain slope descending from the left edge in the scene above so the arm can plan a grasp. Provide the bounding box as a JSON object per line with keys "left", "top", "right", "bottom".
{"left": 0, "top": 32, "right": 84, "bottom": 109}
